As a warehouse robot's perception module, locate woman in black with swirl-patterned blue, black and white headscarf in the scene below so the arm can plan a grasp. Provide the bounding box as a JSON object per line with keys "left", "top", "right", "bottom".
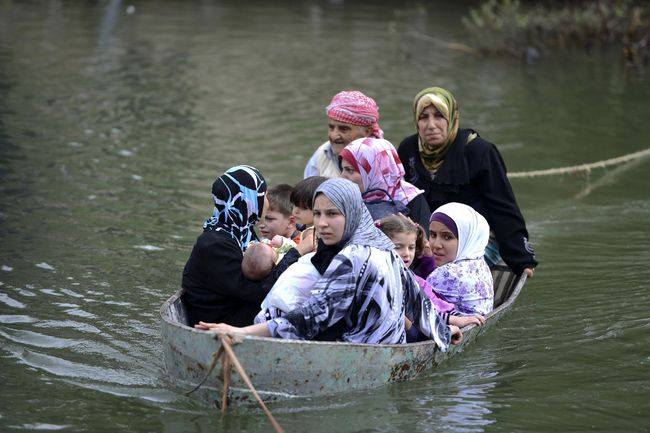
{"left": 182, "top": 165, "right": 307, "bottom": 326}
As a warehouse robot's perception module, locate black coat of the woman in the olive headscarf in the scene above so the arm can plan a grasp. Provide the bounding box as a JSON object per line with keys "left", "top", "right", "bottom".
{"left": 397, "top": 129, "right": 537, "bottom": 274}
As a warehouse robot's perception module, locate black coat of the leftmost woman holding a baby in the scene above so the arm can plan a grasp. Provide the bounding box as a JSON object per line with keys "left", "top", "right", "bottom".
{"left": 182, "top": 230, "right": 300, "bottom": 326}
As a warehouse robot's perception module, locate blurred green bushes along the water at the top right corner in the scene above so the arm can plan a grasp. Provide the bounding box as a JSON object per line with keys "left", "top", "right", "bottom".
{"left": 463, "top": 0, "right": 650, "bottom": 65}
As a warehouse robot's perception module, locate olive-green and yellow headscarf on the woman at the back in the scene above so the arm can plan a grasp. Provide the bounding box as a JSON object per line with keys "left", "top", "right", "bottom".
{"left": 413, "top": 87, "right": 459, "bottom": 173}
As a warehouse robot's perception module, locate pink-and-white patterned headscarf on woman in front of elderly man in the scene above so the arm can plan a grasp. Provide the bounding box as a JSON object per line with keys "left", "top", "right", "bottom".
{"left": 340, "top": 137, "right": 424, "bottom": 205}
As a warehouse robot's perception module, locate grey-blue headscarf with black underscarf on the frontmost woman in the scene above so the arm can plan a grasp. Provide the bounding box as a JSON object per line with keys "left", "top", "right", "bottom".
{"left": 311, "top": 178, "right": 395, "bottom": 274}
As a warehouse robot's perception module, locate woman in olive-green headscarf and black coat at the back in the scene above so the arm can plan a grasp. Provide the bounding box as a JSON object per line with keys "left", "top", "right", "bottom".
{"left": 397, "top": 87, "right": 537, "bottom": 277}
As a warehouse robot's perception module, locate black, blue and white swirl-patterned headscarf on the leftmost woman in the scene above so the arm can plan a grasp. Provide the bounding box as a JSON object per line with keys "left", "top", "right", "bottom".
{"left": 203, "top": 165, "right": 266, "bottom": 251}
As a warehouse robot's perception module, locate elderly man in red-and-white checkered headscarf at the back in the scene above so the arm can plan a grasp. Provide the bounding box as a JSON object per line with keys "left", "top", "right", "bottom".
{"left": 304, "top": 90, "right": 384, "bottom": 178}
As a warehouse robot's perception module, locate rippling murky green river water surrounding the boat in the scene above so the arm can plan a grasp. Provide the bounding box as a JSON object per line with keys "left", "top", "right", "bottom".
{"left": 0, "top": 0, "right": 650, "bottom": 432}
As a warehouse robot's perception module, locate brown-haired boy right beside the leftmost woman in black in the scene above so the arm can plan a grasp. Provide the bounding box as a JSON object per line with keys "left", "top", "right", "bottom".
{"left": 258, "top": 183, "right": 300, "bottom": 243}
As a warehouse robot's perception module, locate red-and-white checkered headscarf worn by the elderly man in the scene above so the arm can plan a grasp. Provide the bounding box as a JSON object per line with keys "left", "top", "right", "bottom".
{"left": 325, "top": 90, "right": 384, "bottom": 138}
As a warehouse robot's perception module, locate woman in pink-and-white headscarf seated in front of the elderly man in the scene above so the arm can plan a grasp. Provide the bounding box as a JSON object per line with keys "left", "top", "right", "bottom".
{"left": 339, "top": 137, "right": 431, "bottom": 234}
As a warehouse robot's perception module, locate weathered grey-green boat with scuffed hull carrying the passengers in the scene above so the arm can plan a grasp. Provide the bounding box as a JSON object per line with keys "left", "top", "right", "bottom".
{"left": 160, "top": 267, "right": 526, "bottom": 406}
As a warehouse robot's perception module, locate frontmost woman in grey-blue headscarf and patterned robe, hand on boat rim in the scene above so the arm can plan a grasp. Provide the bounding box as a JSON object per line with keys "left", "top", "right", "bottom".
{"left": 196, "top": 179, "right": 461, "bottom": 351}
